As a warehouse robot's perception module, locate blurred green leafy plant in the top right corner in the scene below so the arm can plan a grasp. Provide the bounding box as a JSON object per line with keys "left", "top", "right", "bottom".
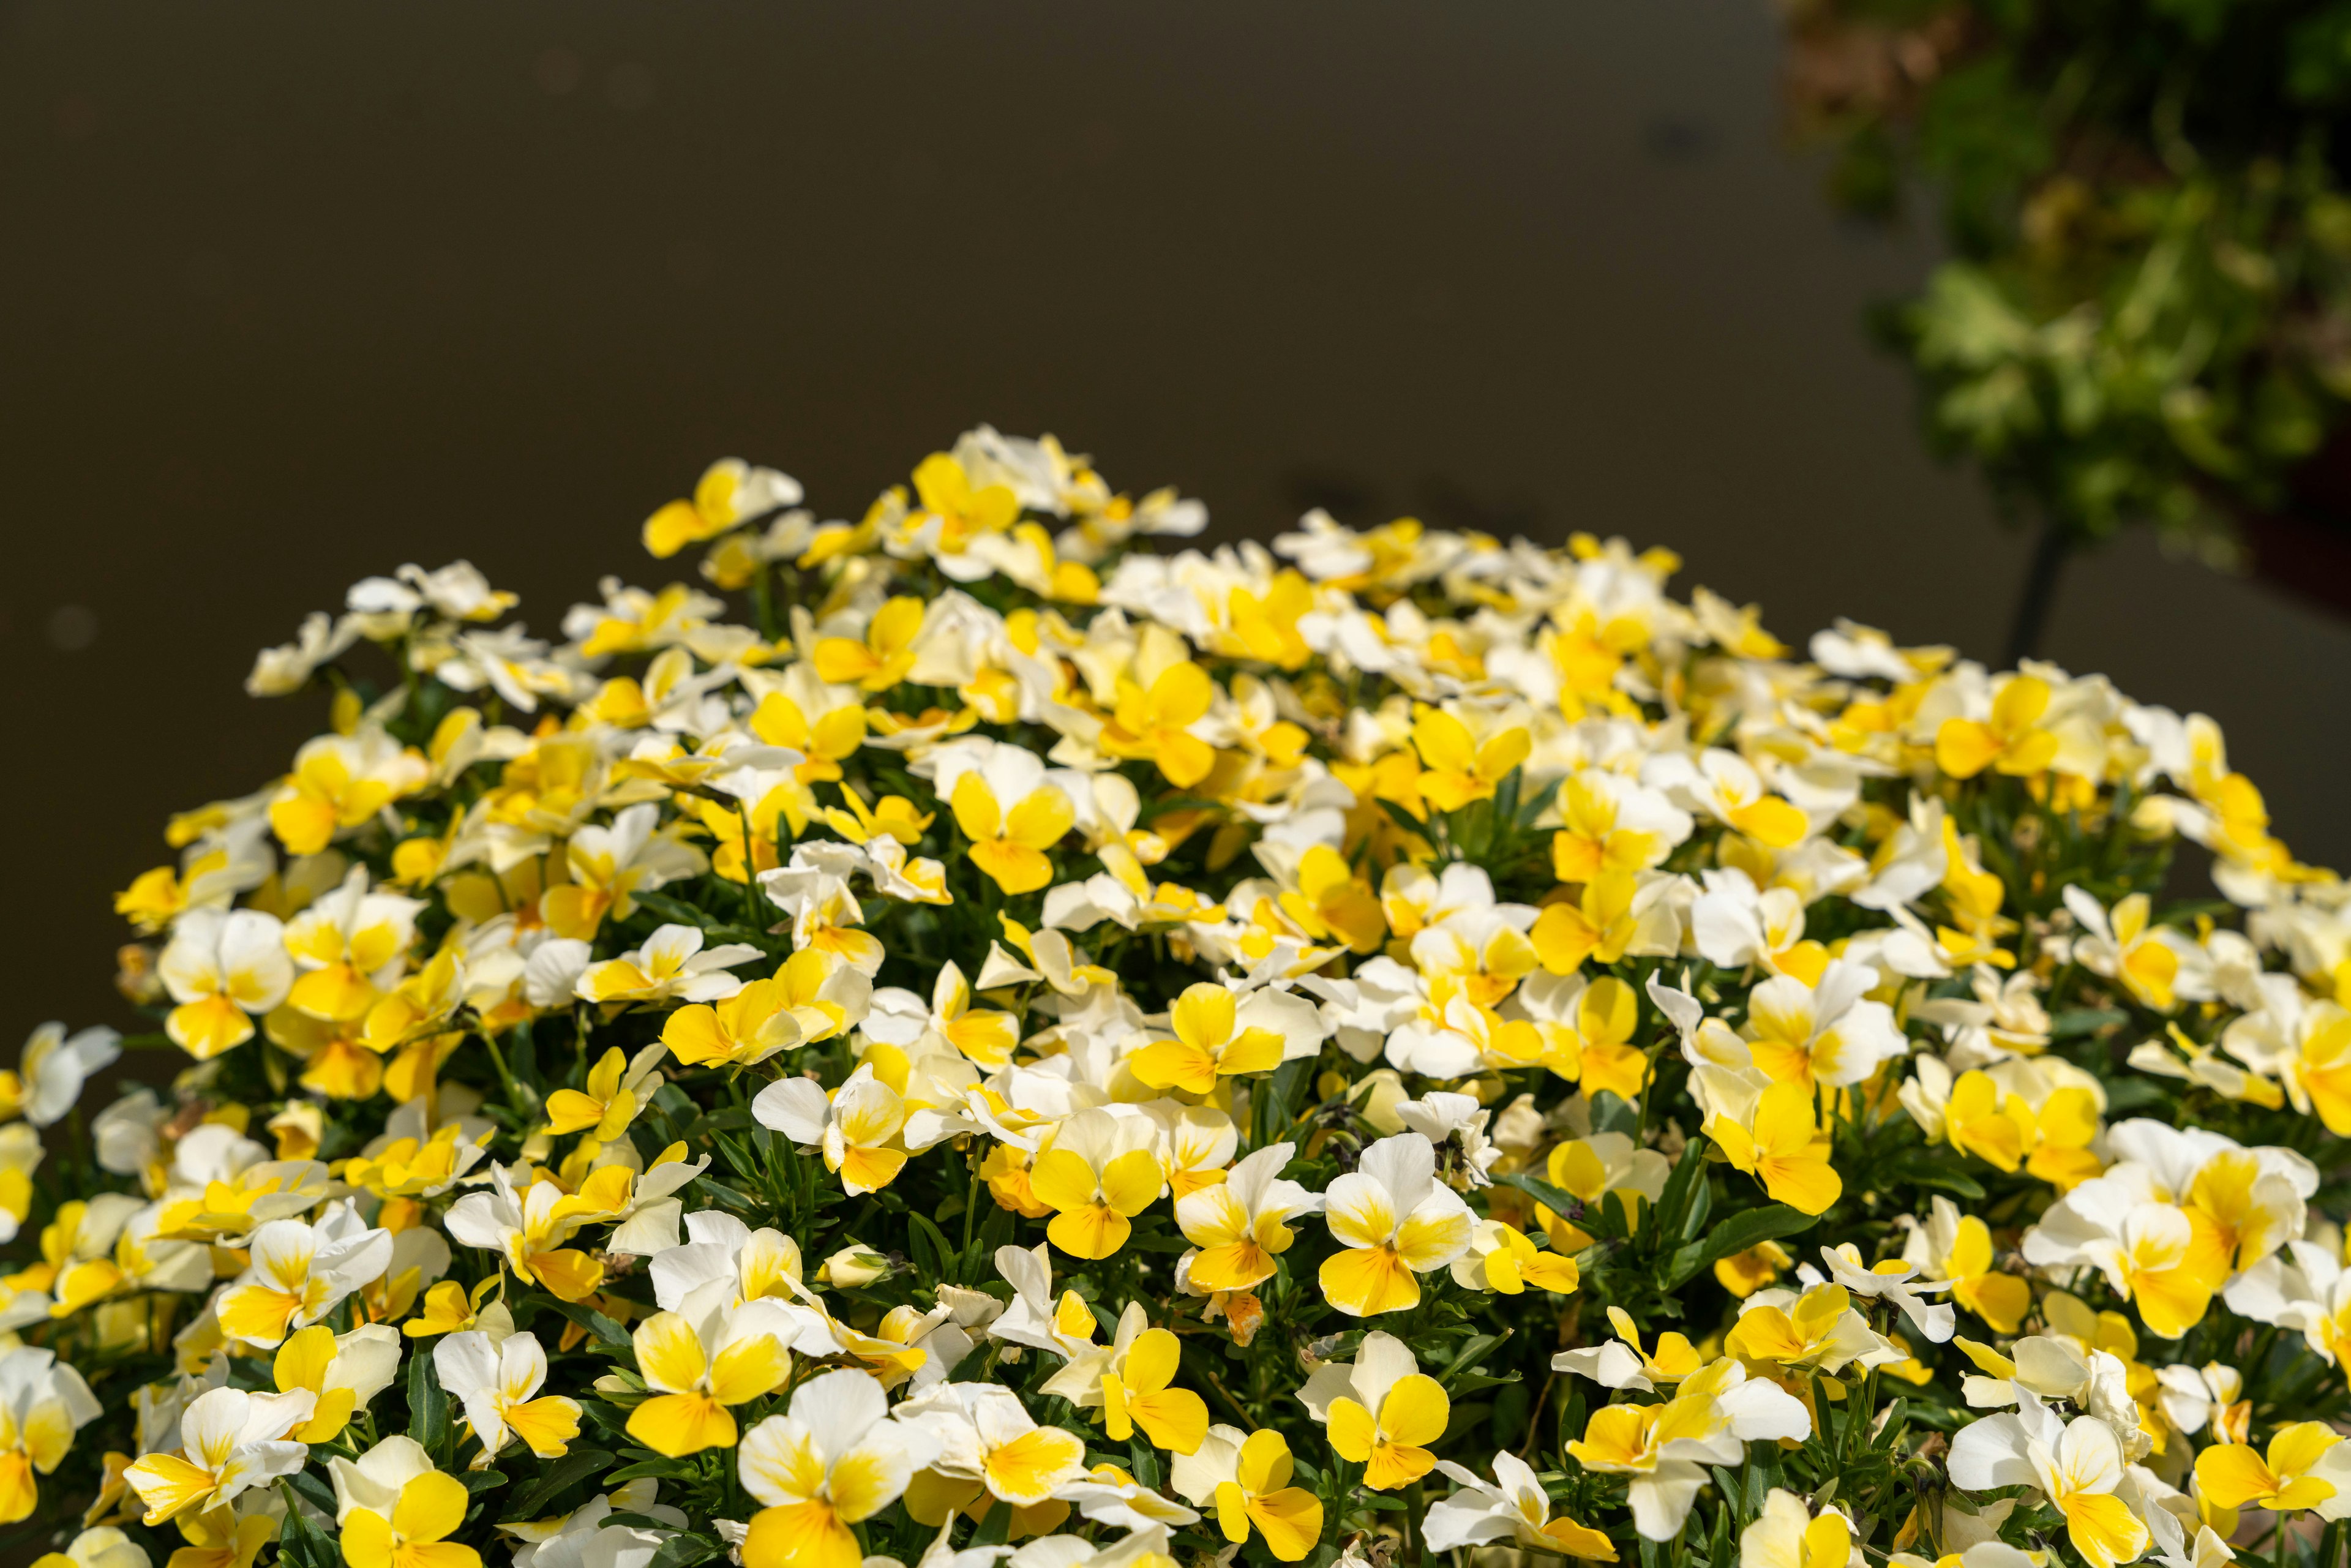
{"left": 1789, "top": 0, "right": 2351, "bottom": 560}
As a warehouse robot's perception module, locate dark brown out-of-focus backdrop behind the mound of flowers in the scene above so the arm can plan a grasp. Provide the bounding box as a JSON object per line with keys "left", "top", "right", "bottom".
{"left": 0, "top": 0, "right": 2351, "bottom": 1053}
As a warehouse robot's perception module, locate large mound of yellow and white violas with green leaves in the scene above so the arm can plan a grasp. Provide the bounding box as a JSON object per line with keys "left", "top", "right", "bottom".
{"left": 0, "top": 428, "right": 2351, "bottom": 1568}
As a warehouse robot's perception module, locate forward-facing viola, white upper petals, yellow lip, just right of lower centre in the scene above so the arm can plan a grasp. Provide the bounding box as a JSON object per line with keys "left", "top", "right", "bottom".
{"left": 1321, "top": 1133, "right": 1474, "bottom": 1316}
